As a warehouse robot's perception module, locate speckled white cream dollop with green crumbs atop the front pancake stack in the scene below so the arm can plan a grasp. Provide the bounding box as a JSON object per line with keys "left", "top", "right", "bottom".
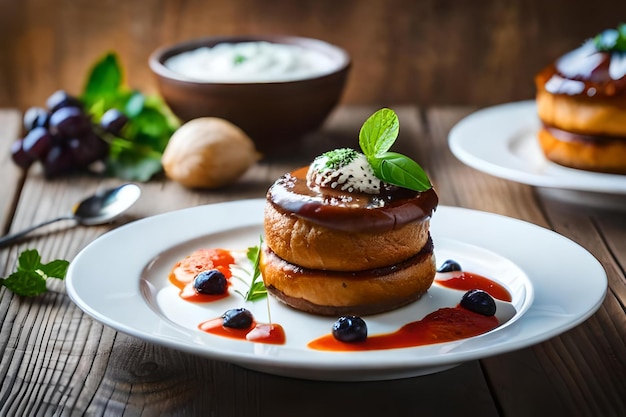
{"left": 306, "top": 149, "right": 382, "bottom": 194}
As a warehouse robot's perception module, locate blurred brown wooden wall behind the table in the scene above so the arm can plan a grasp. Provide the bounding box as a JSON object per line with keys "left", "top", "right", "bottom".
{"left": 0, "top": 0, "right": 626, "bottom": 109}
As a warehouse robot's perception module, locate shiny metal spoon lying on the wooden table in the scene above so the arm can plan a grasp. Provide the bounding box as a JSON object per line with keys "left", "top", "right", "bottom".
{"left": 0, "top": 184, "right": 141, "bottom": 247}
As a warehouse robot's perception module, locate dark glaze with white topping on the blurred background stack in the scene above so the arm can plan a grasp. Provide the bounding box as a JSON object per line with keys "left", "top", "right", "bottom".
{"left": 535, "top": 41, "right": 626, "bottom": 100}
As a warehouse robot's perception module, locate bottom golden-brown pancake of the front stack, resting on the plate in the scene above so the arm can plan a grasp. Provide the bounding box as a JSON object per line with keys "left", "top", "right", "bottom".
{"left": 259, "top": 239, "right": 436, "bottom": 316}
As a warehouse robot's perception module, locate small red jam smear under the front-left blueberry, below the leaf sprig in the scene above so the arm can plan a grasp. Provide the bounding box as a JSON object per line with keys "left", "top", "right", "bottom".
{"left": 198, "top": 317, "right": 286, "bottom": 345}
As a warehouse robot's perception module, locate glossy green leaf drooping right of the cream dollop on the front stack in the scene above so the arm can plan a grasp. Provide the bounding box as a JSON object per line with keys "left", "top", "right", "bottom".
{"left": 372, "top": 152, "right": 432, "bottom": 191}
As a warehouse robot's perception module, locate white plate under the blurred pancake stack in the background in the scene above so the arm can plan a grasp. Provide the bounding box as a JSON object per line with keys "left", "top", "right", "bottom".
{"left": 448, "top": 100, "right": 626, "bottom": 194}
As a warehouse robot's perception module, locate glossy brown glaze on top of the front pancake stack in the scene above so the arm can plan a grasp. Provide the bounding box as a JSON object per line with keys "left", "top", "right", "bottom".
{"left": 267, "top": 167, "right": 439, "bottom": 232}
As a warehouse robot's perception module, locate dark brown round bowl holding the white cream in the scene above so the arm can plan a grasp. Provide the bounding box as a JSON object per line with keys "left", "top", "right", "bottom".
{"left": 150, "top": 36, "right": 351, "bottom": 156}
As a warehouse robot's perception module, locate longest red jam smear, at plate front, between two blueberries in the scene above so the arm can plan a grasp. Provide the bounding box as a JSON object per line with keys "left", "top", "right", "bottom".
{"left": 308, "top": 306, "right": 499, "bottom": 352}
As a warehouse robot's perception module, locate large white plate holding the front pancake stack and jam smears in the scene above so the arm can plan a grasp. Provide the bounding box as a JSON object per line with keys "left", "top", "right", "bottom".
{"left": 66, "top": 199, "right": 607, "bottom": 381}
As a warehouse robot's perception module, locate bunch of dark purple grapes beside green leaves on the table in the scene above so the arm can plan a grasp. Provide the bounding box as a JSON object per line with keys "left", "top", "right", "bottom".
{"left": 11, "top": 90, "right": 128, "bottom": 178}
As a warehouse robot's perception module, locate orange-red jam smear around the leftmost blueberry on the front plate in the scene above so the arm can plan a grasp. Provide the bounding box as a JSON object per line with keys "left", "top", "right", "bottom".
{"left": 169, "top": 249, "right": 235, "bottom": 302}
